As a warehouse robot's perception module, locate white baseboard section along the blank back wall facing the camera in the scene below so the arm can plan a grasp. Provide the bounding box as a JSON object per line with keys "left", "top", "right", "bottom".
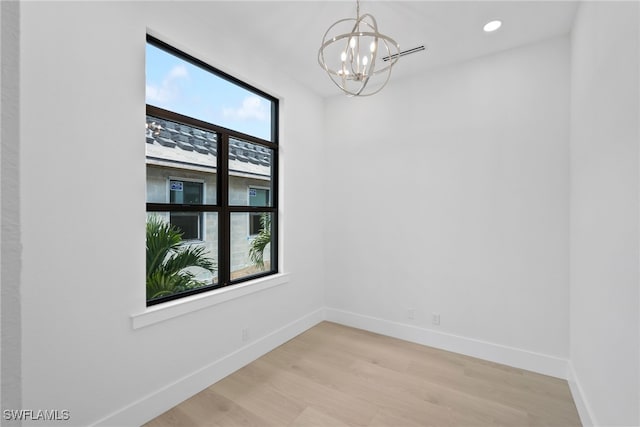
{"left": 325, "top": 308, "right": 568, "bottom": 380}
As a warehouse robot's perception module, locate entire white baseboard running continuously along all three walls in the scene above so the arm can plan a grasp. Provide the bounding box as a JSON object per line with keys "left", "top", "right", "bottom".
{"left": 92, "top": 308, "right": 576, "bottom": 427}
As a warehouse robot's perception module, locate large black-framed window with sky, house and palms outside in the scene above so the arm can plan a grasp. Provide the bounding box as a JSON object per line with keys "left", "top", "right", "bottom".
{"left": 145, "top": 36, "right": 278, "bottom": 305}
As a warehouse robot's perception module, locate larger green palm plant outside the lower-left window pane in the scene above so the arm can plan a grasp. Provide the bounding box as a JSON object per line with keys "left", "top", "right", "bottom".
{"left": 147, "top": 215, "right": 216, "bottom": 300}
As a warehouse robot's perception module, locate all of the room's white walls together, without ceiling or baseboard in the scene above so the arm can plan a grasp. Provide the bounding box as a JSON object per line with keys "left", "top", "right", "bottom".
{"left": 13, "top": 2, "right": 639, "bottom": 425}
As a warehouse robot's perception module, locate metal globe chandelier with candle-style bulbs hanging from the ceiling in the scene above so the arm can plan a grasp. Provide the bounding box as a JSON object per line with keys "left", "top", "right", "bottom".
{"left": 318, "top": 0, "right": 400, "bottom": 96}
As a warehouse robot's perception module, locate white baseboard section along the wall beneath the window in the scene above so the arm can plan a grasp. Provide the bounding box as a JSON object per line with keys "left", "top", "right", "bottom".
{"left": 92, "top": 309, "right": 324, "bottom": 427}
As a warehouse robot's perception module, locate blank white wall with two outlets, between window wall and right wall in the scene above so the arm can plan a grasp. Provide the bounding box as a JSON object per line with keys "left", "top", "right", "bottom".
{"left": 325, "top": 37, "right": 569, "bottom": 368}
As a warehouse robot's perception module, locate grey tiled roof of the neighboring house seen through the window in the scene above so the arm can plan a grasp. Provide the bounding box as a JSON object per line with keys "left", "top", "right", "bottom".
{"left": 146, "top": 116, "right": 272, "bottom": 177}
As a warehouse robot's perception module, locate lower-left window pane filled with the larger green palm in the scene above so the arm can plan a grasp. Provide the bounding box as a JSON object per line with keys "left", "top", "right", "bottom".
{"left": 147, "top": 212, "right": 218, "bottom": 301}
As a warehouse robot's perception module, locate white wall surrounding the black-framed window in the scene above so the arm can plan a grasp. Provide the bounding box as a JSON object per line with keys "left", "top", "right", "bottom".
{"left": 20, "top": 2, "right": 324, "bottom": 425}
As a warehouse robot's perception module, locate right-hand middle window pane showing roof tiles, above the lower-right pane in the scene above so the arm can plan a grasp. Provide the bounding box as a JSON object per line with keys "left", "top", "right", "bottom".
{"left": 229, "top": 138, "right": 273, "bottom": 207}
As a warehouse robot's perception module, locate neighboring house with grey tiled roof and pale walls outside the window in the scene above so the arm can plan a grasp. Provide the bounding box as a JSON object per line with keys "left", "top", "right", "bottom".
{"left": 146, "top": 118, "right": 271, "bottom": 280}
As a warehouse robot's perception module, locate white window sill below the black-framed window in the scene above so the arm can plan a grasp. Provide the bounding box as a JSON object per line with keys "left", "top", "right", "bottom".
{"left": 131, "top": 273, "right": 289, "bottom": 329}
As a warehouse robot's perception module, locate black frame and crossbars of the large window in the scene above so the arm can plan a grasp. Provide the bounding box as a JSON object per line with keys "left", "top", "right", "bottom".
{"left": 146, "top": 34, "right": 279, "bottom": 307}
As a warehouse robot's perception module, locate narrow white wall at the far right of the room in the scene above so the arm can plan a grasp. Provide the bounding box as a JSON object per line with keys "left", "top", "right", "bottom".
{"left": 571, "top": 2, "right": 640, "bottom": 425}
